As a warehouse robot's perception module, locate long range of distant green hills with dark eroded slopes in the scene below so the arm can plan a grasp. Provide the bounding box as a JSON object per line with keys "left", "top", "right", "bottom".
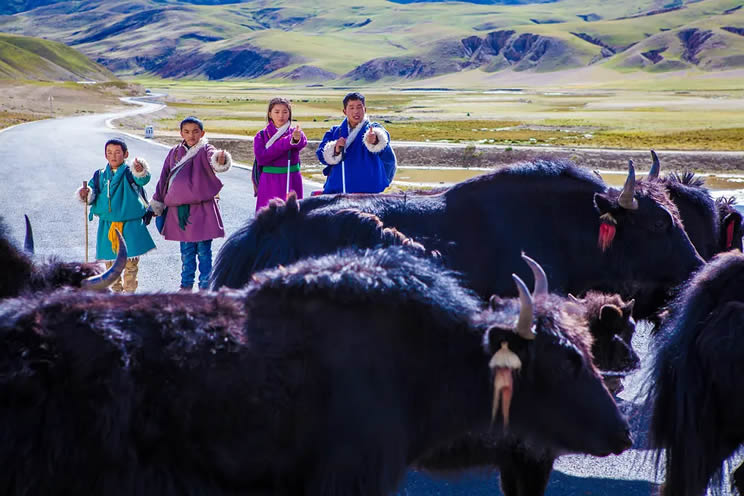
{"left": 0, "top": 0, "right": 744, "bottom": 84}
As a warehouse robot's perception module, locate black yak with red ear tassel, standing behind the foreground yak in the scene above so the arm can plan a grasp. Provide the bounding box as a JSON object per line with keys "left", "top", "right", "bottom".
{"left": 212, "top": 161, "right": 703, "bottom": 317}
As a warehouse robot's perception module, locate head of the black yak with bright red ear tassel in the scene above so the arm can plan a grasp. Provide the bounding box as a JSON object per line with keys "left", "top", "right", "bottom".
{"left": 594, "top": 160, "right": 704, "bottom": 318}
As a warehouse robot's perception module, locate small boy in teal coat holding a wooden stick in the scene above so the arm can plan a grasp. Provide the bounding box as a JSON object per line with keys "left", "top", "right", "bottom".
{"left": 75, "top": 139, "right": 155, "bottom": 293}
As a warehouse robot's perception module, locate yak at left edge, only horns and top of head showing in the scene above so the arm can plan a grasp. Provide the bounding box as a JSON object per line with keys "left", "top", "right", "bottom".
{"left": 0, "top": 217, "right": 127, "bottom": 299}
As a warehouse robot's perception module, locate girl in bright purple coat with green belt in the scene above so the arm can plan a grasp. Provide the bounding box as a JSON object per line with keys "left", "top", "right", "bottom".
{"left": 253, "top": 98, "right": 307, "bottom": 211}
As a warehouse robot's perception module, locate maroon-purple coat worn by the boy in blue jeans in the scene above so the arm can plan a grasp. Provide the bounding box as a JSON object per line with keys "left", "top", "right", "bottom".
{"left": 152, "top": 138, "right": 231, "bottom": 242}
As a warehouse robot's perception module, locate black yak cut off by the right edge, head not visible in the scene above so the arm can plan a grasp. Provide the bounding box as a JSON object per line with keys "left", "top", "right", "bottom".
{"left": 647, "top": 251, "right": 744, "bottom": 496}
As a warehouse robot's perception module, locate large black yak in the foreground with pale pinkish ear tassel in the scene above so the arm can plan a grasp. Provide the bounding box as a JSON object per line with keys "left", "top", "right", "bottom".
{"left": 0, "top": 248, "right": 631, "bottom": 496}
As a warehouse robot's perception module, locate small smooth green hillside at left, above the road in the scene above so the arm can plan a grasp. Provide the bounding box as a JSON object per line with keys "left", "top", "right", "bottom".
{"left": 0, "top": 33, "right": 116, "bottom": 81}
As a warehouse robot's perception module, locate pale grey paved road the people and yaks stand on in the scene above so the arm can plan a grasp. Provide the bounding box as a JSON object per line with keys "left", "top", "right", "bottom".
{"left": 0, "top": 98, "right": 736, "bottom": 496}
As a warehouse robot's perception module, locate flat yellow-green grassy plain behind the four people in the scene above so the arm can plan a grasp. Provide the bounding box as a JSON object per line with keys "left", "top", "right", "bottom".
{"left": 123, "top": 78, "right": 744, "bottom": 150}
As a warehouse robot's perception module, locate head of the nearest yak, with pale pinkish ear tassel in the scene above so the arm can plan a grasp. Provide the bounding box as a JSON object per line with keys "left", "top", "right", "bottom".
{"left": 484, "top": 255, "right": 632, "bottom": 456}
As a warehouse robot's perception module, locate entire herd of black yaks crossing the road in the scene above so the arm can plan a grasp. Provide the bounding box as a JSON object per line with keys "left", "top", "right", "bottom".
{"left": 0, "top": 155, "right": 744, "bottom": 496}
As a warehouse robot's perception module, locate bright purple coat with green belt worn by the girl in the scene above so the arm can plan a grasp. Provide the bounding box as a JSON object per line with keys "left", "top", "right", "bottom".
{"left": 253, "top": 121, "right": 307, "bottom": 211}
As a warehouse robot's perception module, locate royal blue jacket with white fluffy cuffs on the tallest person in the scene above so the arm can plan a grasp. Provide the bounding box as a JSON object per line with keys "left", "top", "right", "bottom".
{"left": 315, "top": 119, "right": 396, "bottom": 193}
